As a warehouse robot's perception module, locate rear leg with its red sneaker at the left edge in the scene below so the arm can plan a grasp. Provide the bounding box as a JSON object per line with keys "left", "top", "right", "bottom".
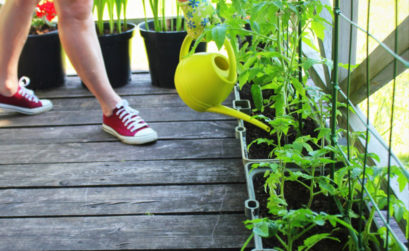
{"left": 0, "top": 0, "right": 53, "bottom": 115}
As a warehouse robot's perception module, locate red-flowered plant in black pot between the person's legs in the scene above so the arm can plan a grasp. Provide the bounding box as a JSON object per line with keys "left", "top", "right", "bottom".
{"left": 18, "top": 0, "right": 65, "bottom": 89}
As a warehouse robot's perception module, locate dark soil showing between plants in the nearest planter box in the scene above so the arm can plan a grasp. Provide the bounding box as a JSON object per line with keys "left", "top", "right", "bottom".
{"left": 253, "top": 174, "right": 349, "bottom": 251}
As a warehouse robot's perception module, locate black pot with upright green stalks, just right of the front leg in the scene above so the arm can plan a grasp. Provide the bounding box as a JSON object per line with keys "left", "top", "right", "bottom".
{"left": 94, "top": 0, "right": 136, "bottom": 88}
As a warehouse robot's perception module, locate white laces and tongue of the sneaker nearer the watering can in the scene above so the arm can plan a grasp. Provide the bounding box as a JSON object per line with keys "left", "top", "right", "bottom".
{"left": 116, "top": 100, "right": 147, "bottom": 132}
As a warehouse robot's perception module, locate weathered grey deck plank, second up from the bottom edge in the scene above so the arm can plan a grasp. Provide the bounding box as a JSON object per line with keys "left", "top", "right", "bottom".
{"left": 0, "top": 184, "right": 246, "bottom": 217}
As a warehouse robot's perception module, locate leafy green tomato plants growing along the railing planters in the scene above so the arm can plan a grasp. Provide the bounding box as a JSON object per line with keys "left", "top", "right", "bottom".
{"left": 196, "top": 0, "right": 409, "bottom": 250}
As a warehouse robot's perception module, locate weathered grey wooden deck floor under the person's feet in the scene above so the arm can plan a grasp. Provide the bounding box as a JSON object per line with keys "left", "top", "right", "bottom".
{"left": 0, "top": 73, "right": 249, "bottom": 251}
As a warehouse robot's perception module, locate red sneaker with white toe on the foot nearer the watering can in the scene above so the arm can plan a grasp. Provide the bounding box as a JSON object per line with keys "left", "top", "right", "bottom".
{"left": 102, "top": 100, "right": 158, "bottom": 145}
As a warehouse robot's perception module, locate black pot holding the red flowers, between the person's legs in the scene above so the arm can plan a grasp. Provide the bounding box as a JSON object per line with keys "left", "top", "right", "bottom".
{"left": 18, "top": 30, "right": 65, "bottom": 90}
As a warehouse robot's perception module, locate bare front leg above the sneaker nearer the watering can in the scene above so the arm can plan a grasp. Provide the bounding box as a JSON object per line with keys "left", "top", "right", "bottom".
{"left": 55, "top": 0, "right": 121, "bottom": 116}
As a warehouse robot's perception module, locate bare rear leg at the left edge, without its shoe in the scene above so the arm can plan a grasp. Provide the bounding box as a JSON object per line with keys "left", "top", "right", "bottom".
{"left": 0, "top": 0, "right": 39, "bottom": 96}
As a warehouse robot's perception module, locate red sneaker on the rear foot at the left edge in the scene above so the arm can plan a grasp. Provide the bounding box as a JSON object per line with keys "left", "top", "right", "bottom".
{"left": 0, "top": 77, "right": 53, "bottom": 115}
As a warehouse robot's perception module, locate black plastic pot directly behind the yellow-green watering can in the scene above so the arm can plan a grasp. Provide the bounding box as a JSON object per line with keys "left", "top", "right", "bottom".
{"left": 139, "top": 19, "right": 206, "bottom": 88}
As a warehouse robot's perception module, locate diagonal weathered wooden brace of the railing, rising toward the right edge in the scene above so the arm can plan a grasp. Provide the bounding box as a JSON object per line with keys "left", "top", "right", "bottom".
{"left": 340, "top": 17, "right": 409, "bottom": 104}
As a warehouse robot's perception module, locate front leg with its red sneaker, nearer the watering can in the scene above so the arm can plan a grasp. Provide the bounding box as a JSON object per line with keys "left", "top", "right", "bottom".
{"left": 55, "top": 0, "right": 158, "bottom": 144}
